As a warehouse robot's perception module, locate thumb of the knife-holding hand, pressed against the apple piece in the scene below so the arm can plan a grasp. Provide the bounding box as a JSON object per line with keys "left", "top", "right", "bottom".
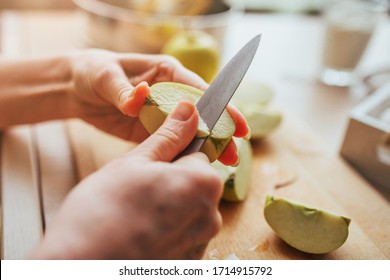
{"left": 131, "top": 100, "right": 198, "bottom": 162}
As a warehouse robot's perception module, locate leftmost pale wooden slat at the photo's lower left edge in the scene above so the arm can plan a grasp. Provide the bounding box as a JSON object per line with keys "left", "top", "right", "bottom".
{"left": 0, "top": 126, "right": 43, "bottom": 259}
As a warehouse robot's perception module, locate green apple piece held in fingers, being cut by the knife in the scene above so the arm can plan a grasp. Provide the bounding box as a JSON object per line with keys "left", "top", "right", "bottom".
{"left": 139, "top": 82, "right": 236, "bottom": 162}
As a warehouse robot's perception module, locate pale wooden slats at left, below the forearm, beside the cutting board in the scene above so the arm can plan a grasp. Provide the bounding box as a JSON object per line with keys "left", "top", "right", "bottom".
{"left": 0, "top": 121, "right": 78, "bottom": 260}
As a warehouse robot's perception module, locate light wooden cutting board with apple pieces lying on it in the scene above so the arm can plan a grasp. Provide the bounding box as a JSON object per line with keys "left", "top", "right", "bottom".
{"left": 67, "top": 117, "right": 390, "bottom": 259}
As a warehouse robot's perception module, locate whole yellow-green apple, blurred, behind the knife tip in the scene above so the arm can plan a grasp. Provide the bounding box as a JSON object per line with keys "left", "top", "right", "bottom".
{"left": 161, "top": 30, "right": 220, "bottom": 83}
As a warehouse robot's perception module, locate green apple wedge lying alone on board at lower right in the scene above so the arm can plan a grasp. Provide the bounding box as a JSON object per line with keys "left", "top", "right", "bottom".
{"left": 264, "top": 196, "right": 351, "bottom": 254}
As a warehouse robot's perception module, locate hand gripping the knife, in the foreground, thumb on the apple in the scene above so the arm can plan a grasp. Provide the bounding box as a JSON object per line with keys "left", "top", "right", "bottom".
{"left": 33, "top": 101, "right": 222, "bottom": 259}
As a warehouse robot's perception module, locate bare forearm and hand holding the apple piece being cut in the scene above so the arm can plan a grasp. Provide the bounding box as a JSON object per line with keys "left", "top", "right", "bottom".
{"left": 0, "top": 50, "right": 250, "bottom": 165}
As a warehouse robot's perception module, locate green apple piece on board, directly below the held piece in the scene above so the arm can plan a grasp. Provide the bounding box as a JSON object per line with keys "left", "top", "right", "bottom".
{"left": 211, "top": 138, "right": 253, "bottom": 201}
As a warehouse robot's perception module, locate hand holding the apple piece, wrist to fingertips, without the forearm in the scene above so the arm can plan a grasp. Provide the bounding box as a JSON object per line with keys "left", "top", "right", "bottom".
{"left": 71, "top": 50, "right": 249, "bottom": 165}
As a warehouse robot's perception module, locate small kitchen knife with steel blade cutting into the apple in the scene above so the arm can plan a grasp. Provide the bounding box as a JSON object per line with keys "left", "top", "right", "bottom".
{"left": 176, "top": 34, "right": 261, "bottom": 158}
